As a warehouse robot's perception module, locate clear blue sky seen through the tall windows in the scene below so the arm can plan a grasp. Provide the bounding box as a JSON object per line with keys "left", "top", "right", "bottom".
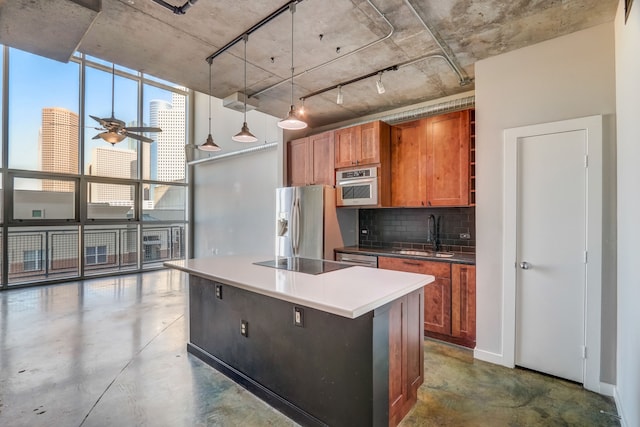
{"left": 0, "top": 49, "right": 178, "bottom": 174}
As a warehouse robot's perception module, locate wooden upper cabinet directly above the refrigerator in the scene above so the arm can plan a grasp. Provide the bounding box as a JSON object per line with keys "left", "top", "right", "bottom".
{"left": 287, "top": 131, "right": 335, "bottom": 186}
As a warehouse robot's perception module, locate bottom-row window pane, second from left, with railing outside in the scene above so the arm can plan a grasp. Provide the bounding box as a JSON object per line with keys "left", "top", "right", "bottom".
{"left": 84, "top": 225, "right": 138, "bottom": 276}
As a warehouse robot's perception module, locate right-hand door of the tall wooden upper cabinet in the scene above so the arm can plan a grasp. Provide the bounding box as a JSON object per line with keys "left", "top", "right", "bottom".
{"left": 426, "top": 110, "right": 469, "bottom": 206}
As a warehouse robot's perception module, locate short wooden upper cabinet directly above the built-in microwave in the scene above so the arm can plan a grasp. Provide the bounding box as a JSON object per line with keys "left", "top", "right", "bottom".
{"left": 335, "top": 121, "right": 390, "bottom": 169}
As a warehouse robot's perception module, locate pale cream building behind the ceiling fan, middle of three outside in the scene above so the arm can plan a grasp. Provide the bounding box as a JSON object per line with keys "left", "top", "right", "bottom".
{"left": 88, "top": 147, "right": 137, "bottom": 206}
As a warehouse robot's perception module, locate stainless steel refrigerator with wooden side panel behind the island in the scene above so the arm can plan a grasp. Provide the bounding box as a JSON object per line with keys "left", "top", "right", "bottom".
{"left": 276, "top": 185, "right": 358, "bottom": 260}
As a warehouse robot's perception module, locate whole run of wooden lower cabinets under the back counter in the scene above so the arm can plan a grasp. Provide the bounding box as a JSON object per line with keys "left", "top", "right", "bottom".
{"left": 378, "top": 256, "right": 476, "bottom": 348}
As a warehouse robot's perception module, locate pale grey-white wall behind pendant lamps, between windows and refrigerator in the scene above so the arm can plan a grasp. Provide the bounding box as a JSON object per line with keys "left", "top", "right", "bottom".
{"left": 190, "top": 93, "right": 283, "bottom": 257}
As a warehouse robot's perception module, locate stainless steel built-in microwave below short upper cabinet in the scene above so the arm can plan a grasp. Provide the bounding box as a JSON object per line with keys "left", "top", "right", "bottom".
{"left": 336, "top": 167, "right": 378, "bottom": 206}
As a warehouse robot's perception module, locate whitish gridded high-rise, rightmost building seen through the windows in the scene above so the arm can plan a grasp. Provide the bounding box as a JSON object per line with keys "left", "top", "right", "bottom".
{"left": 150, "top": 93, "right": 186, "bottom": 181}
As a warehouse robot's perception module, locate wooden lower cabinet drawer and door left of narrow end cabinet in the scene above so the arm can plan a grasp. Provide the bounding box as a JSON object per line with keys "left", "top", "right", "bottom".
{"left": 378, "top": 257, "right": 451, "bottom": 335}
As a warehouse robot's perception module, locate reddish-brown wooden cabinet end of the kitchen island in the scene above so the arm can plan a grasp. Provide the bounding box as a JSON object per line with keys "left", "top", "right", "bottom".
{"left": 389, "top": 290, "right": 424, "bottom": 426}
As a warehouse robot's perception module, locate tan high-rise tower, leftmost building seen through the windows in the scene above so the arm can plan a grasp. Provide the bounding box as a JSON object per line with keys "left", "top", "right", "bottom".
{"left": 38, "top": 107, "right": 79, "bottom": 192}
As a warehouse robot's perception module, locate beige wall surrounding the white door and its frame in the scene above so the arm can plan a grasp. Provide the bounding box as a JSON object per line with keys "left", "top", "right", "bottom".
{"left": 475, "top": 23, "right": 616, "bottom": 384}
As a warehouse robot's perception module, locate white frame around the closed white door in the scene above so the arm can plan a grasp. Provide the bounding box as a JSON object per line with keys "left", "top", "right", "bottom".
{"left": 502, "top": 115, "right": 603, "bottom": 393}
